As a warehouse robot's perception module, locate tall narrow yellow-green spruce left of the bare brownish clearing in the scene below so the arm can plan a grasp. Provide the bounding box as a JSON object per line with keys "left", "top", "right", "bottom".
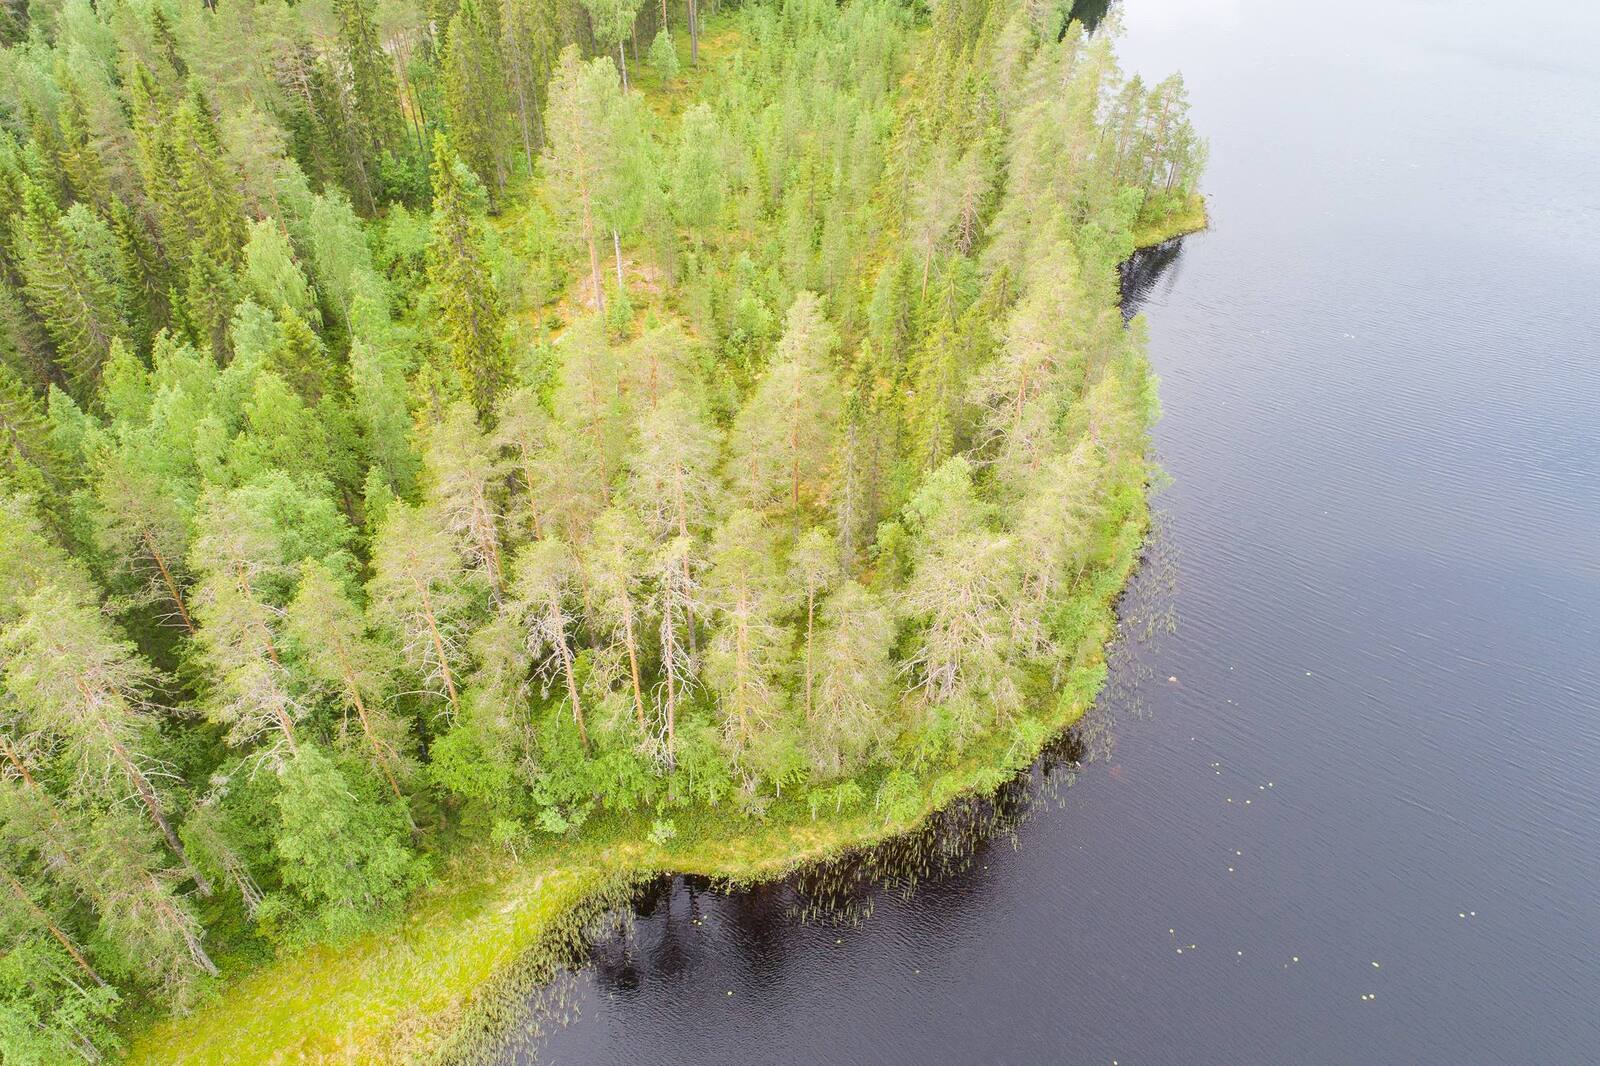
{"left": 427, "top": 134, "right": 512, "bottom": 418}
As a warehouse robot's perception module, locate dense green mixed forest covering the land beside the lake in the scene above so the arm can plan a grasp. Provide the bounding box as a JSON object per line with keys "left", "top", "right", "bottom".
{"left": 0, "top": 0, "right": 1205, "bottom": 1066}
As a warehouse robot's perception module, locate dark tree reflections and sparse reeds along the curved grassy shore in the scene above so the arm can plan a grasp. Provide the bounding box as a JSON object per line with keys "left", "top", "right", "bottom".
{"left": 499, "top": 521, "right": 1178, "bottom": 1063}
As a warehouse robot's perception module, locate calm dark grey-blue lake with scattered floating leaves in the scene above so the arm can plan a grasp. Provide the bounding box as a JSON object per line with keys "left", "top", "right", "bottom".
{"left": 507, "top": 0, "right": 1600, "bottom": 1066}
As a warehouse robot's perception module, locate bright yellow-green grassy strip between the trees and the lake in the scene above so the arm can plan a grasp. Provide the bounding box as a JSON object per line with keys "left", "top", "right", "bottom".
{"left": 128, "top": 473, "right": 1149, "bottom": 1066}
